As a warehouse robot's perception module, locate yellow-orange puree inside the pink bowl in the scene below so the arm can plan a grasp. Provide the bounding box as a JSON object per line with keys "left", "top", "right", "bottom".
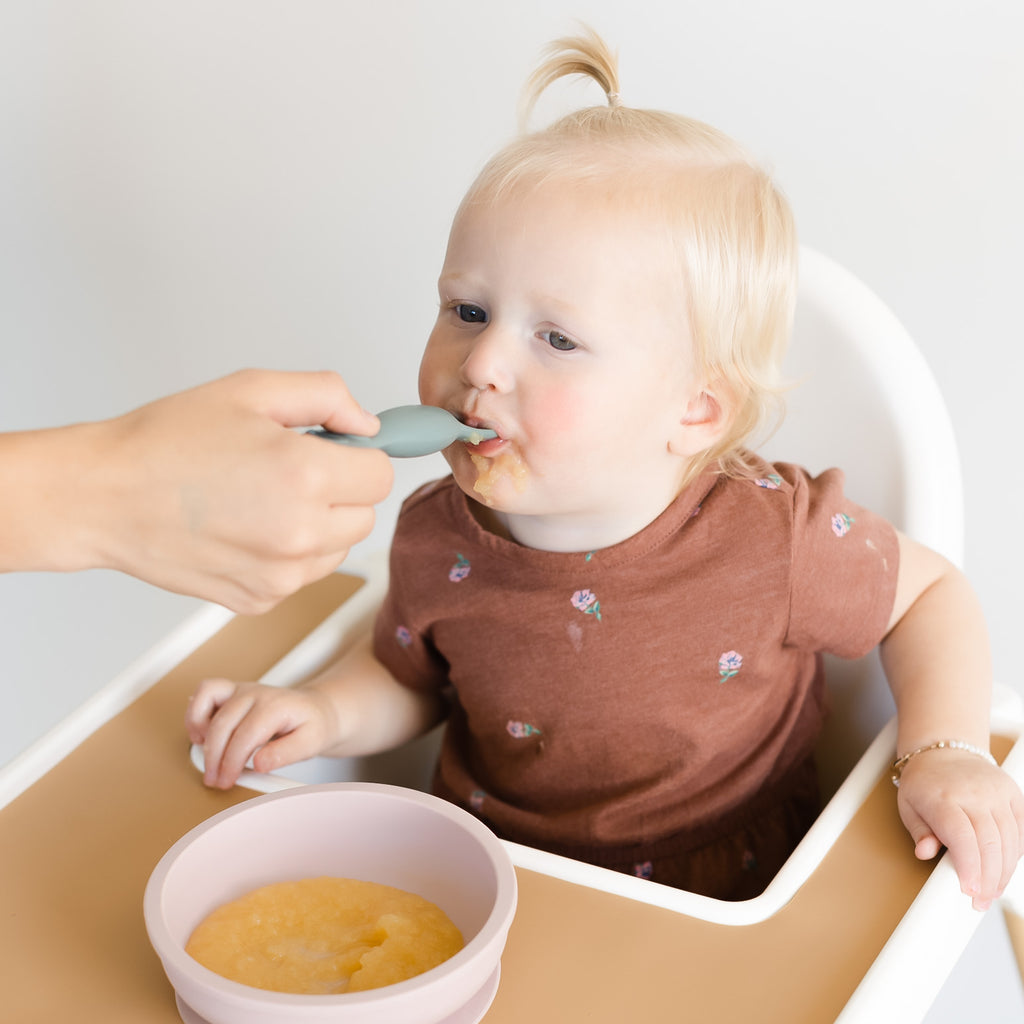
{"left": 185, "top": 878, "right": 463, "bottom": 995}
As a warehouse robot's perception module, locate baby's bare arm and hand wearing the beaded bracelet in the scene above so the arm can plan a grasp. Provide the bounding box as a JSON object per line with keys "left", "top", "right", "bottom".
{"left": 882, "top": 535, "right": 1024, "bottom": 909}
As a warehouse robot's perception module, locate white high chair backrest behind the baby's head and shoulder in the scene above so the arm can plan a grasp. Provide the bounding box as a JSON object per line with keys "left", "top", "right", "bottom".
{"left": 762, "top": 247, "right": 964, "bottom": 796}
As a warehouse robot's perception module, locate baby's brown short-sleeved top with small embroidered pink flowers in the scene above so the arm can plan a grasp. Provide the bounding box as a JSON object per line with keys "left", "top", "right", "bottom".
{"left": 375, "top": 463, "right": 898, "bottom": 846}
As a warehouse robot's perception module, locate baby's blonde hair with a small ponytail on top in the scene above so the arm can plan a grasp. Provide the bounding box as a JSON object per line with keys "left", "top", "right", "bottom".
{"left": 463, "top": 29, "right": 797, "bottom": 475}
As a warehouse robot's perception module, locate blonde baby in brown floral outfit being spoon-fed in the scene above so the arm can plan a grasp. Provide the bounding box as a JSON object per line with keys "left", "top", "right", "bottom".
{"left": 186, "top": 24, "right": 1024, "bottom": 908}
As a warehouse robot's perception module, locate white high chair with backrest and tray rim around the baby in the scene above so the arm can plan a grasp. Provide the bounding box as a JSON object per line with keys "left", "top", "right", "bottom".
{"left": 6, "top": 243, "right": 1024, "bottom": 1024}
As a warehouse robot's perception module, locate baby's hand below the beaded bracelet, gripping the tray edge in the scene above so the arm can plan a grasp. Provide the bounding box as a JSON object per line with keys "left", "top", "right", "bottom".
{"left": 897, "top": 749, "right": 1024, "bottom": 910}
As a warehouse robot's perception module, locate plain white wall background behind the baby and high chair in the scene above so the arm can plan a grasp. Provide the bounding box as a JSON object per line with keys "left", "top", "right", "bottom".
{"left": 0, "top": 0, "right": 1024, "bottom": 1024}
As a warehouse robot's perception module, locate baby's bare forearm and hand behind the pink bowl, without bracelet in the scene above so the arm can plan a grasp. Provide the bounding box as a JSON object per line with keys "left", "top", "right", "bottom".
{"left": 185, "top": 634, "right": 441, "bottom": 790}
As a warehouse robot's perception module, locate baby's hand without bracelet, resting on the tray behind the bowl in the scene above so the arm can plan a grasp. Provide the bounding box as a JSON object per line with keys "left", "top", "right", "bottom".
{"left": 185, "top": 679, "right": 334, "bottom": 790}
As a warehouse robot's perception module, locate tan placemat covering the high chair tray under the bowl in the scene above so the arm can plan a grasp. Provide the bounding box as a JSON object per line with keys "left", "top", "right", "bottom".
{"left": 0, "top": 575, "right": 983, "bottom": 1024}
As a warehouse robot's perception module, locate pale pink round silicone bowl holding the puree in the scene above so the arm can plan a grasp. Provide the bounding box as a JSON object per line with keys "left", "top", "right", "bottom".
{"left": 143, "top": 782, "right": 516, "bottom": 1024}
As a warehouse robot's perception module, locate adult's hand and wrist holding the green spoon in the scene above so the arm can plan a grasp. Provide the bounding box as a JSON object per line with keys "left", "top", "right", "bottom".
{"left": 0, "top": 370, "right": 393, "bottom": 612}
